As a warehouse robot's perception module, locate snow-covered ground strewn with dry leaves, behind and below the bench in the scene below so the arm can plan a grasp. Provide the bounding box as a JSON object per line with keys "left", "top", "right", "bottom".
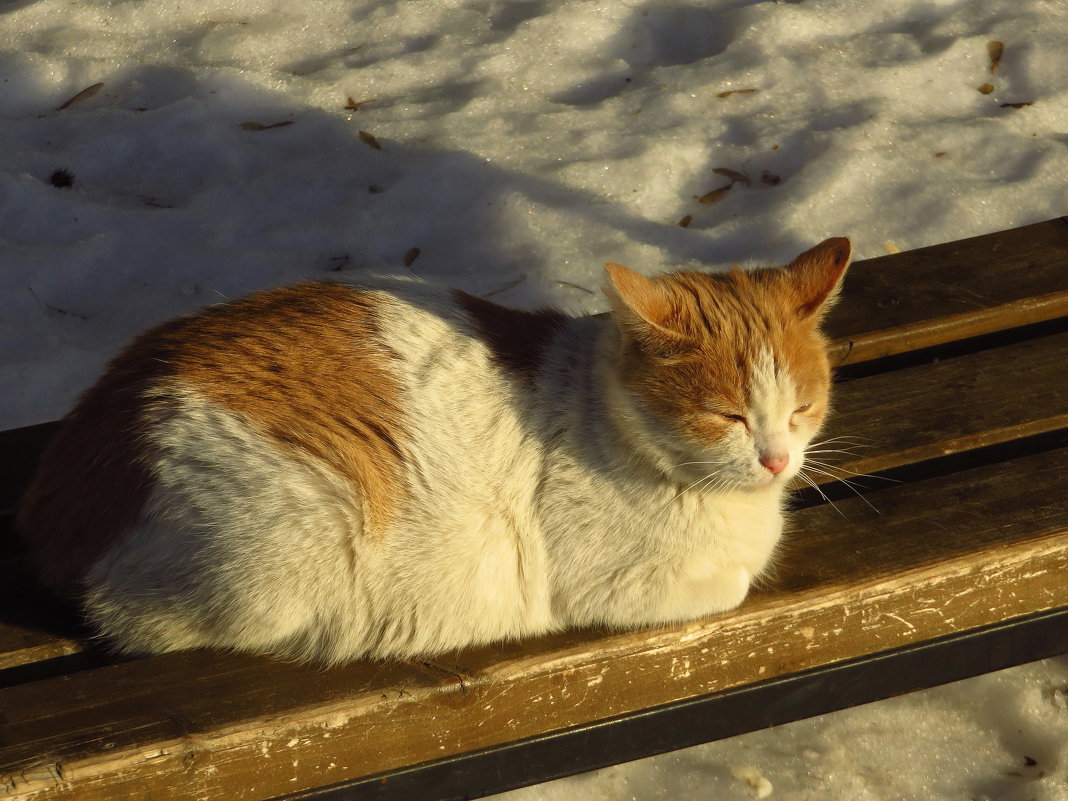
{"left": 0, "top": 0, "right": 1068, "bottom": 801}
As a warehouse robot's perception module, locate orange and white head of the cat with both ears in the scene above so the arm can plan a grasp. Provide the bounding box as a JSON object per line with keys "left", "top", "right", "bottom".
{"left": 606, "top": 238, "right": 851, "bottom": 488}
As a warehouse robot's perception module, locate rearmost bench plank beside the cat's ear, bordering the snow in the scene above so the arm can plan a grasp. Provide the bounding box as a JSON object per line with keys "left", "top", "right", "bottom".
{"left": 828, "top": 218, "right": 1068, "bottom": 364}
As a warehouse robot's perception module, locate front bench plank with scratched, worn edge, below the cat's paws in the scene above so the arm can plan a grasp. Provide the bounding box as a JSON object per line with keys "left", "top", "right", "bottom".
{"left": 0, "top": 450, "right": 1068, "bottom": 801}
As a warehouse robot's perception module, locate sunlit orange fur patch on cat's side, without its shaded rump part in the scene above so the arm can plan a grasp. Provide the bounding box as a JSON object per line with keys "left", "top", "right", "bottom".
{"left": 161, "top": 283, "right": 405, "bottom": 540}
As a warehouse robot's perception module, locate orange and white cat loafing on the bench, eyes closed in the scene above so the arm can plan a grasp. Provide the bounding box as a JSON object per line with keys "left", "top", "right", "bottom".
{"left": 17, "top": 238, "right": 851, "bottom": 663}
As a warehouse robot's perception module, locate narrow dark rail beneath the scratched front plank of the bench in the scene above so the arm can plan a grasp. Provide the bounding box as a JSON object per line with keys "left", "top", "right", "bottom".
{"left": 285, "top": 608, "right": 1068, "bottom": 801}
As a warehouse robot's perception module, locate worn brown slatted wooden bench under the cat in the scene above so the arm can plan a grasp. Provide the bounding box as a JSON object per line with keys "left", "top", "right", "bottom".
{"left": 0, "top": 220, "right": 1068, "bottom": 801}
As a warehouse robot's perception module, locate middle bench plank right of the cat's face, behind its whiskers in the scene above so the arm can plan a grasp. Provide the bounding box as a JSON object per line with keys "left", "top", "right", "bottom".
{"left": 811, "top": 326, "right": 1068, "bottom": 486}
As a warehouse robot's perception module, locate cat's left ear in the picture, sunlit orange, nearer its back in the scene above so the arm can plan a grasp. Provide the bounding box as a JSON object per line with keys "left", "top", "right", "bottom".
{"left": 604, "top": 262, "right": 688, "bottom": 356}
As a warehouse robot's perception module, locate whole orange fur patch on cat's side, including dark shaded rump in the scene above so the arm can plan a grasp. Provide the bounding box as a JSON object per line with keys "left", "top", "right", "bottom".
{"left": 17, "top": 283, "right": 404, "bottom": 587}
